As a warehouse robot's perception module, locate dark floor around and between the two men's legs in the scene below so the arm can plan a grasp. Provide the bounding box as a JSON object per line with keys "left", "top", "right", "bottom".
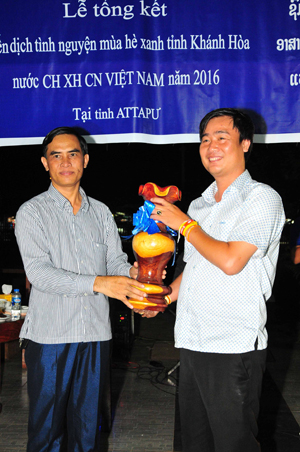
{"left": 0, "top": 303, "right": 300, "bottom": 452}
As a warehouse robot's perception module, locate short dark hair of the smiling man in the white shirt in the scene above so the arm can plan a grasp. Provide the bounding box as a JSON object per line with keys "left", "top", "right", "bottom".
{"left": 199, "top": 108, "right": 254, "bottom": 162}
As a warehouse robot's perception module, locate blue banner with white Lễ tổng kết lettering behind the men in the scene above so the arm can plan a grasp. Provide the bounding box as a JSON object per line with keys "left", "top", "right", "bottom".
{"left": 0, "top": 0, "right": 300, "bottom": 145}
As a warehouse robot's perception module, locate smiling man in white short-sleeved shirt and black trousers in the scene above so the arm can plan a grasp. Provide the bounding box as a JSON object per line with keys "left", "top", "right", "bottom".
{"left": 149, "top": 108, "right": 285, "bottom": 452}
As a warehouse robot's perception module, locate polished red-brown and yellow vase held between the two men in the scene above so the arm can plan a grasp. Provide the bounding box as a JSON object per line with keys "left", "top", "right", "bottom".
{"left": 129, "top": 182, "right": 181, "bottom": 311}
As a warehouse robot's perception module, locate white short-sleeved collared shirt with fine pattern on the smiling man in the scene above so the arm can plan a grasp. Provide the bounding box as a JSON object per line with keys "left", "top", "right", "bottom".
{"left": 175, "top": 171, "right": 285, "bottom": 353}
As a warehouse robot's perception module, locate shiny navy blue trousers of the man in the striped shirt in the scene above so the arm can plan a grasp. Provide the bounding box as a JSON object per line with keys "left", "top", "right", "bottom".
{"left": 25, "top": 341, "right": 110, "bottom": 452}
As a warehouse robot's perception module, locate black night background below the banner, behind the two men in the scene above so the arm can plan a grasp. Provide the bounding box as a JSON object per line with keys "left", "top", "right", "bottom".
{"left": 0, "top": 143, "right": 300, "bottom": 294}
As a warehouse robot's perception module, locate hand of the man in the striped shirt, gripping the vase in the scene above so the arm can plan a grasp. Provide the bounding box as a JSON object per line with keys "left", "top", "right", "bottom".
{"left": 93, "top": 276, "right": 147, "bottom": 309}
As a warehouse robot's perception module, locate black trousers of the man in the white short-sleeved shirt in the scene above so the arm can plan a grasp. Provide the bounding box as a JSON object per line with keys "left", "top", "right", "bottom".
{"left": 179, "top": 349, "right": 266, "bottom": 452}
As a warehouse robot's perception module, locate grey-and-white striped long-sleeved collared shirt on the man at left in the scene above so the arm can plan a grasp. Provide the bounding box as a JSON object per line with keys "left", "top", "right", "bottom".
{"left": 15, "top": 184, "right": 131, "bottom": 344}
